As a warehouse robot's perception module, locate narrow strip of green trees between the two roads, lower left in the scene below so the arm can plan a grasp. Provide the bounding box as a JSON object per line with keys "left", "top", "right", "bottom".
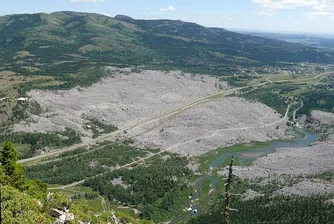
{"left": 26, "top": 143, "right": 148, "bottom": 184}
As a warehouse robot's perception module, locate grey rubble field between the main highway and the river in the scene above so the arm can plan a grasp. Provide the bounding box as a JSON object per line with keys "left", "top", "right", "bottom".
{"left": 135, "top": 97, "right": 286, "bottom": 156}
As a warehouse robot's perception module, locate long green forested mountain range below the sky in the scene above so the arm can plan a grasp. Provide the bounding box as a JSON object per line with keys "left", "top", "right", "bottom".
{"left": 0, "top": 12, "right": 334, "bottom": 75}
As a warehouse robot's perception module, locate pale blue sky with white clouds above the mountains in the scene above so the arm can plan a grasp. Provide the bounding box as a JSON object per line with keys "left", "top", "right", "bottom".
{"left": 0, "top": 0, "right": 334, "bottom": 33}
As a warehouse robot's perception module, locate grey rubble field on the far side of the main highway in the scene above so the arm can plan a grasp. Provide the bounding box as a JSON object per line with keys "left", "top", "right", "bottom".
{"left": 14, "top": 68, "right": 216, "bottom": 136}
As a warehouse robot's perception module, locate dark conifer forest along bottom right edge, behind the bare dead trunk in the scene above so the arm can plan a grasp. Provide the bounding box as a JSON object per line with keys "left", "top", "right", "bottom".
{"left": 187, "top": 196, "right": 334, "bottom": 224}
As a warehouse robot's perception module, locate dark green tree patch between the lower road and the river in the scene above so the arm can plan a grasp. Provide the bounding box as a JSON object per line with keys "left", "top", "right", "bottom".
{"left": 84, "top": 155, "right": 193, "bottom": 222}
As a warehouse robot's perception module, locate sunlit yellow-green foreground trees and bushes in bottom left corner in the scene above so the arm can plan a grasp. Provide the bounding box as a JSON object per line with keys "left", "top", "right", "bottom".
{"left": 0, "top": 141, "right": 152, "bottom": 224}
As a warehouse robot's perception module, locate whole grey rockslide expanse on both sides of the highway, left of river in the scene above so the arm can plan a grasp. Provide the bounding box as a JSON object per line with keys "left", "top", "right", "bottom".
{"left": 14, "top": 68, "right": 289, "bottom": 156}
